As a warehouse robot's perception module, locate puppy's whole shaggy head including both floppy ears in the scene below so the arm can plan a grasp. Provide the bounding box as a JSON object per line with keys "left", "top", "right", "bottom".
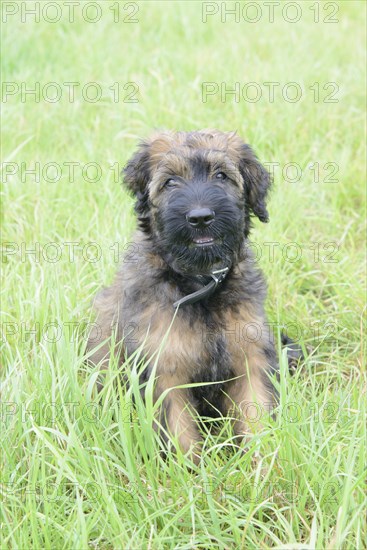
{"left": 124, "top": 130, "right": 269, "bottom": 274}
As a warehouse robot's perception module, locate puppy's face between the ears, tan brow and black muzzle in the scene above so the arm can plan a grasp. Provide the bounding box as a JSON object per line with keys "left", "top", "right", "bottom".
{"left": 150, "top": 151, "right": 245, "bottom": 273}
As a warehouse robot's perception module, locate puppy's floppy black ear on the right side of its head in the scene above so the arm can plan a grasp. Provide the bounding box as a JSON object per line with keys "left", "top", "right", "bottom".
{"left": 239, "top": 144, "right": 272, "bottom": 226}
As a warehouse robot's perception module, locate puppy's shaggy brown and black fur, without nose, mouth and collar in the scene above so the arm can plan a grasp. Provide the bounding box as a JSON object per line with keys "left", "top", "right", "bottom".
{"left": 88, "top": 130, "right": 300, "bottom": 464}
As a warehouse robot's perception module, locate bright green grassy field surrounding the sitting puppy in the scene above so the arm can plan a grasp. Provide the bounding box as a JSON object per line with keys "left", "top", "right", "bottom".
{"left": 1, "top": 1, "right": 366, "bottom": 550}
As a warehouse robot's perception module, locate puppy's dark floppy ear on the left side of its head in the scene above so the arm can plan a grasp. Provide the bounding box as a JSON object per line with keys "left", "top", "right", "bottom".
{"left": 122, "top": 141, "right": 150, "bottom": 195}
